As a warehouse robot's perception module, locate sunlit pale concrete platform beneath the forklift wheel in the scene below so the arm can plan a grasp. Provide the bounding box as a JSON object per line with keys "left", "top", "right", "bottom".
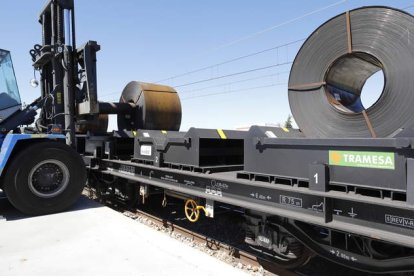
{"left": 0, "top": 198, "right": 245, "bottom": 276}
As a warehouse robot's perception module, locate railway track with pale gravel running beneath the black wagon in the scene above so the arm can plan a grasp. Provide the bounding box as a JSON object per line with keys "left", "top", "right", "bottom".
{"left": 119, "top": 203, "right": 398, "bottom": 276}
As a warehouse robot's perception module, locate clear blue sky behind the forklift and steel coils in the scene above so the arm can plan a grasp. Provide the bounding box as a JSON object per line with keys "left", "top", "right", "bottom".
{"left": 0, "top": 0, "right": 414, "bottom": 130}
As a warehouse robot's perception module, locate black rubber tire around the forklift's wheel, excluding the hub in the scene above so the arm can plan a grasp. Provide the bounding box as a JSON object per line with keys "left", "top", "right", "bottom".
{"left": 3, "top": 141, "right": 86, "bottom": 215}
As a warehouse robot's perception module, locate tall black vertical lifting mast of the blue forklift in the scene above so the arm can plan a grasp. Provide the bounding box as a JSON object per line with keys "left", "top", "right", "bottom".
{"left": 30, "top": 0, "right": 100, "bottom": 147}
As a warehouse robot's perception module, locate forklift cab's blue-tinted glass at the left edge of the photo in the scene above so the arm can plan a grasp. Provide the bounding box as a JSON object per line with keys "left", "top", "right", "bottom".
{"left": 0, "top": 49, "right": 21, "bottom": 122}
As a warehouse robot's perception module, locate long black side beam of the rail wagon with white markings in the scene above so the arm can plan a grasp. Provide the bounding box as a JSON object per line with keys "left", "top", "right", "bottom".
{"left": 90, "top": 157, "right": 414, "bottom": 248}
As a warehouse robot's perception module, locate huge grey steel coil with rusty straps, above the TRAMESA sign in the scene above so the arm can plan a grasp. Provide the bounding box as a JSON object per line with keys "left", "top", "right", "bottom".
{"left": 289, "top": 7, "right": 414, "bottom": 138}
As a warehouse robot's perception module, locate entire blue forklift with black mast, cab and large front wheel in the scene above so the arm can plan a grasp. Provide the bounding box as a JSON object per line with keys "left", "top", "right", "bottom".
{"left": 0, "top": 0, "right": 107, "bottom": 215}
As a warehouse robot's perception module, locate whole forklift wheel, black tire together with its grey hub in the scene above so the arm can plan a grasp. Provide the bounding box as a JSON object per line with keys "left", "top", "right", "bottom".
{"left": 4, "top": 141, "right": 86, "bottom": 216}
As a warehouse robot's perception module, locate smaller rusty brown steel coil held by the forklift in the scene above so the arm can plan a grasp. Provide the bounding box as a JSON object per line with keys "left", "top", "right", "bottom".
{"left": 118, "top": 81, "right": 181, "bottom": 130}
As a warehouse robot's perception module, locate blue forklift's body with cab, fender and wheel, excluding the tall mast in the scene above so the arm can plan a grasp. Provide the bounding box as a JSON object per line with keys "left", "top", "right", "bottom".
{"left": 0, "top": 49, "right": 86, "bottom": 215}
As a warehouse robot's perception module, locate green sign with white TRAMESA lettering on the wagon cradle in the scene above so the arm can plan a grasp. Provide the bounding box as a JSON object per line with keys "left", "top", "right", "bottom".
{"left": 329, "top": 150, "right": 395, "bottom": 170}
